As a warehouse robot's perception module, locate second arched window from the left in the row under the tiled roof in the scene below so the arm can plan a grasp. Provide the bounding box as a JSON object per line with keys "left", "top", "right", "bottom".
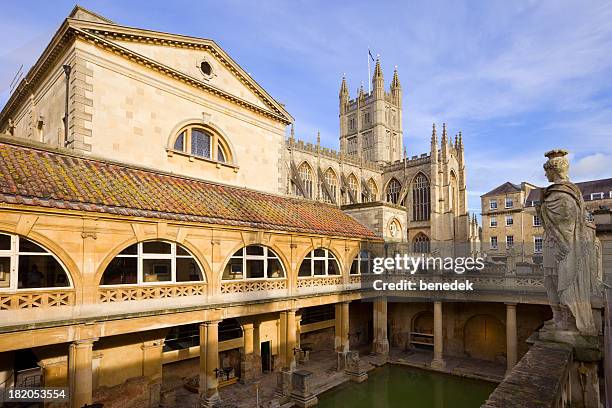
{"left": 100, "top": 241, "right": 204, "bottom": 285}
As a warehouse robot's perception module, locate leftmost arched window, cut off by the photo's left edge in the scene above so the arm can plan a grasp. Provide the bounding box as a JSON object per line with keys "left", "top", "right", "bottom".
{"left": 0, "top": 234, "right": 72, "bottom": 291}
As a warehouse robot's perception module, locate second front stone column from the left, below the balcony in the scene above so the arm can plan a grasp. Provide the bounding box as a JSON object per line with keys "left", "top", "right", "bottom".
{"left": 199, "top": 320, "right": 221, "bottom": 407}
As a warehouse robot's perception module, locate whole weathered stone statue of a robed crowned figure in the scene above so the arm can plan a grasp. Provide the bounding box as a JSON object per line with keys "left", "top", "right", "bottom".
{"left": 538, "top": 150, "right": 597, "bottom": 335}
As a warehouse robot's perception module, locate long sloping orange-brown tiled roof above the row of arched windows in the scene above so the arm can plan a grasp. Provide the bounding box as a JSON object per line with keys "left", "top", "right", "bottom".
{"left": 0, "top": 142, "right": 377, "bottom": 238}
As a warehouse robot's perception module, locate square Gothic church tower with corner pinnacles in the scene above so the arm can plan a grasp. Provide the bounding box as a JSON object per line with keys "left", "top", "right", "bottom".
{"left": 339, "top": 59, "right": 404, "bottom": 164}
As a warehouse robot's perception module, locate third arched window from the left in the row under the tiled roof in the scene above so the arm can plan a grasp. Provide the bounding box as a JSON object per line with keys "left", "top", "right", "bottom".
{"left": 223, "top": 245, "right": 285, "bottom": 280}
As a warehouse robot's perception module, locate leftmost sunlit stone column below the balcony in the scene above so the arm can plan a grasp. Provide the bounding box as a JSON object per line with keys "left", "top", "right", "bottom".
{"left": 68, "top": 339, "right": 97, "bottom": 408}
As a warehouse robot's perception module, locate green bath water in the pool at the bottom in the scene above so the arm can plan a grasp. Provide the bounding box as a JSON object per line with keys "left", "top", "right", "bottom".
{"left": 318, "top": 364, "right": 495, "bottom": 408}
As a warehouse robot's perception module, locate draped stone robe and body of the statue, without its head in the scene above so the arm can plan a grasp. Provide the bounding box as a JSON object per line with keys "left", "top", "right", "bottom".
{"left": 540, "top": 182, "right": 597, "bottom": 334}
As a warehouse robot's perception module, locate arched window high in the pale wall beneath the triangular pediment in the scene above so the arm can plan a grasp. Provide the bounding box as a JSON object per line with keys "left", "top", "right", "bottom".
{"left": 172, "top": 125, "right": 232, "bottom": 163}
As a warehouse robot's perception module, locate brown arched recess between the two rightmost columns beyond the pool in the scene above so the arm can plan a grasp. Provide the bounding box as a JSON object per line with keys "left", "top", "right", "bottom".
{"left": 463, "top": 315, "right": 506, "bottom": 361}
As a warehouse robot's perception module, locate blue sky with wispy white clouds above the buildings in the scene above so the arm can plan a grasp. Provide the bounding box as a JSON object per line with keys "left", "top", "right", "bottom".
{"left": 0, "top": 0, "right": 612, "bottom": 217}
